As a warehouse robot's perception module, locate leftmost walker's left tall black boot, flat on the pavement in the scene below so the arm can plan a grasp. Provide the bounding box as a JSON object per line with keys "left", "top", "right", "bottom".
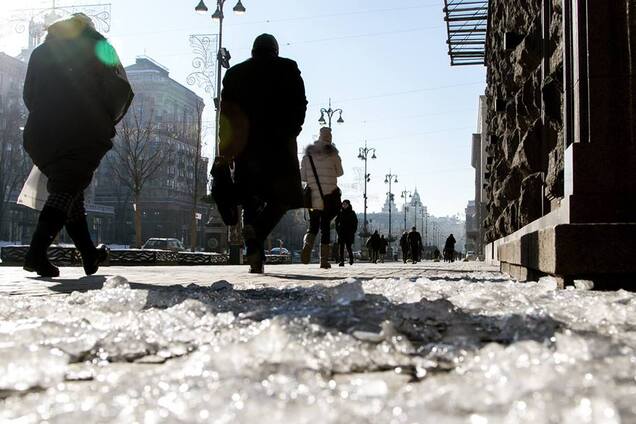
{"left": 23, "top": 206, "right": 66, "bottom": 278}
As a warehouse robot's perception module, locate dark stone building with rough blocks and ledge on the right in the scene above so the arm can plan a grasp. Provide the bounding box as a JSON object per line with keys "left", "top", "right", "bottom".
{"left": 449, "top": 0, "right": 636, "bottom": 284}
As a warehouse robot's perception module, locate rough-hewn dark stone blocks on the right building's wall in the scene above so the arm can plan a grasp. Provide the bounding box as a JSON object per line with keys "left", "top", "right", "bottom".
{"left": 484, "top": 0, "right": 564, "bottom": 242}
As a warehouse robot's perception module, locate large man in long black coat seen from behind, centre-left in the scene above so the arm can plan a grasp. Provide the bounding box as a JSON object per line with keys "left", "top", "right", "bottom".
{"left": 220, "top": 34, "right": 307, "bottom": 273}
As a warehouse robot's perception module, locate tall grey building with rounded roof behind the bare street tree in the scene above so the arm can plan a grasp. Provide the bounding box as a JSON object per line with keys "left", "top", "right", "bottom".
{"left": 97, "top": 57, "right": 226, "bottom": 250}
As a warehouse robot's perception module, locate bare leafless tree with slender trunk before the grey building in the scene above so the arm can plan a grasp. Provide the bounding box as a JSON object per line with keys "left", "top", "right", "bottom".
{"left": 109, "top": 102, "right": 170, "bottom": 247}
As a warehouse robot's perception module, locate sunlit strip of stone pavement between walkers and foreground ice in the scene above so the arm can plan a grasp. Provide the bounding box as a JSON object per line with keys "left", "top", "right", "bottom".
{"left": 0, "top": 261, "right": 498, "bottom": 296}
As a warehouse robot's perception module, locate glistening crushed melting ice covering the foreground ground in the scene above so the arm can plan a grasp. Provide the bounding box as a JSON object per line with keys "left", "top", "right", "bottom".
{"left": 0, "top": 273, "right": 636, "bottom": 424}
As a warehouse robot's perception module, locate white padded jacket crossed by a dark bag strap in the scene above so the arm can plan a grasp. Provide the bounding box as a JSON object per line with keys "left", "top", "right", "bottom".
{"left": 300, "top": 140, "right": 344, "bottom": 210}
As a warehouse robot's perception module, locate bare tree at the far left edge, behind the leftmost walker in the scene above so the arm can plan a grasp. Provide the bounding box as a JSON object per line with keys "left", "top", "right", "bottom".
{"left": 0, "top": 97, "right": 32, "bottom": 237}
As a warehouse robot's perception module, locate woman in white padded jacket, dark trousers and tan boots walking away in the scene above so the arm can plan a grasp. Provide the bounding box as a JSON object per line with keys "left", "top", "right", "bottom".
{"left": 300, "top": 127, "right": 344, "bottom": 268}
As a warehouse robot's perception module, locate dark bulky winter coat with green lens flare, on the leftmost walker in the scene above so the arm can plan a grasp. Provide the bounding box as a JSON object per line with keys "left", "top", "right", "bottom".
{"left": 23, "top": 20, "right": 132, "bottom": 193}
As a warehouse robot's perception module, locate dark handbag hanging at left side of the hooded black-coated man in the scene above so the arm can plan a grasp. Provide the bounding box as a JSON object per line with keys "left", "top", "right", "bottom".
{"left": 210, "top": 156, "right": 239, "bottom": 226}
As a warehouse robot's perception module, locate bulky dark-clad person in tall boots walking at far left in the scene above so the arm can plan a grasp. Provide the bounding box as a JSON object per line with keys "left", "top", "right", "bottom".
{"left": 23, "top": 13, "right": 133, "bottom": 277}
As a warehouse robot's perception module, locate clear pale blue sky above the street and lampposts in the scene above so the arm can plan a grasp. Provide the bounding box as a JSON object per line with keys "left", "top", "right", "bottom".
{"left": 0, "top": 0, "right": 485, "bottom": 216}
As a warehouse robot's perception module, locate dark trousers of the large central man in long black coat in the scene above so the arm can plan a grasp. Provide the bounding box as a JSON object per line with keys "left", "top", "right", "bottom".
{"left": 243, "top": 199, "right": 287, "bottom": 257}
